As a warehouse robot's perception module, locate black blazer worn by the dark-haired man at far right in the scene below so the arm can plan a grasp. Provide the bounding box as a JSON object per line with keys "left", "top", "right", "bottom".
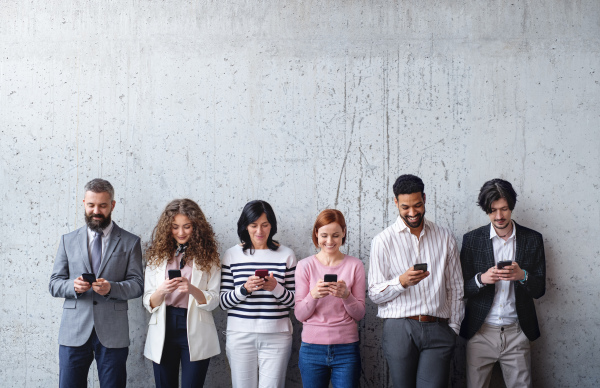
{"left": 460, "top": 222, "right": 546, "bottom": 341}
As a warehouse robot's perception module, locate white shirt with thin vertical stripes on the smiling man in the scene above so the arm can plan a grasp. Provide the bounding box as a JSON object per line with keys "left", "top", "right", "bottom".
{"left": 369, "top": 217, "right": 464, "bottom": 334}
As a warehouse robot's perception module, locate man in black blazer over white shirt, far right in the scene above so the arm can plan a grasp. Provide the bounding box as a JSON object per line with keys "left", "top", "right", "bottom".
{"left": 460, "top": 179, "right": 546, "bottom": 388}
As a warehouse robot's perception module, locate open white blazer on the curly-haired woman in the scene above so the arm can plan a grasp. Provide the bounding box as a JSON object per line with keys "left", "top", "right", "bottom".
{"left": 143, "top": 261, "right": 221, "bottom": 364}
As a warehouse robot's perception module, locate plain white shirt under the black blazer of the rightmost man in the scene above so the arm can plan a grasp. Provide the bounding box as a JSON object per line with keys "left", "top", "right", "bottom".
{"left": 475, "top": 221, "right": 517, "bottom": 326}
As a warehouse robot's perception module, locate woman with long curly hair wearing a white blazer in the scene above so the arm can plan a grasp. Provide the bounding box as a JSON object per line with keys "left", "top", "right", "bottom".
{"left": 143, "top": 199, "right": 221, "bottom": 388}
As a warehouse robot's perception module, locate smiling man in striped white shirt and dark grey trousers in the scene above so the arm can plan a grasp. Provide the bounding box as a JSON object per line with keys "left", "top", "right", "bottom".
{"left": 369, "top": 175, "right": 464, "bottom": 388}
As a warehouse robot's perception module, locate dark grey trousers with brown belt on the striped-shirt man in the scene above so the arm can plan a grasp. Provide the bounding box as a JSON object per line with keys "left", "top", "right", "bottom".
{"left": 383, "top": 318, "right": 457, "bottom": 388}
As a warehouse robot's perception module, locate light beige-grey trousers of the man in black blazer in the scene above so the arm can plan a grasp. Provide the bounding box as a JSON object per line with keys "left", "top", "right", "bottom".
{"left": 467, "top": 323, "right": 531, "bottom": 388}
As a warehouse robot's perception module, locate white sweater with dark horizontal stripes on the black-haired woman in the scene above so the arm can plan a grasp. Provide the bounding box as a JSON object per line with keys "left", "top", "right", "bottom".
{"left": 220, "top": 245, "right": 296, "bottom": 333}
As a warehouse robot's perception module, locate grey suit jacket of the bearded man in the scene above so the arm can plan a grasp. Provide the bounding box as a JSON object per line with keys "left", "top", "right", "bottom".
{"left": 49, "top": 223, "right": 144, "bottom": 348}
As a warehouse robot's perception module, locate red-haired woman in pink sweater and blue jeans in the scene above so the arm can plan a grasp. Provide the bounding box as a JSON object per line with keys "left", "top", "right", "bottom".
{"left": 295, "top": 209, "right": 366, "bottom": 388}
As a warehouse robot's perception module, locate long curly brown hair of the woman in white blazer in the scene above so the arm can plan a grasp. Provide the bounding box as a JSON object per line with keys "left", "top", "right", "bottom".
{"left": 146, "top": 198, "right": 220, "bottom": 272}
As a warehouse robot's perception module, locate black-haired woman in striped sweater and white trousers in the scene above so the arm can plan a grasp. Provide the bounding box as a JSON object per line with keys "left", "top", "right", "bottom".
{"left": 220, "top": 201, "right": 296, "bottom": 388}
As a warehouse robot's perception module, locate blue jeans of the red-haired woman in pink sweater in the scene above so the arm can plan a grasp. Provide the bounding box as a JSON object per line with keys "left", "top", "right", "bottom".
{"left": 298, "top": 342, "right": 361, "bottom": 388}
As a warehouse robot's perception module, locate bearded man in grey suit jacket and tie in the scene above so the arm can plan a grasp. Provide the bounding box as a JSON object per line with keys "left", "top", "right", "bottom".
{"left": 49, "top": 179, "right": 144, "bottom": 388}
